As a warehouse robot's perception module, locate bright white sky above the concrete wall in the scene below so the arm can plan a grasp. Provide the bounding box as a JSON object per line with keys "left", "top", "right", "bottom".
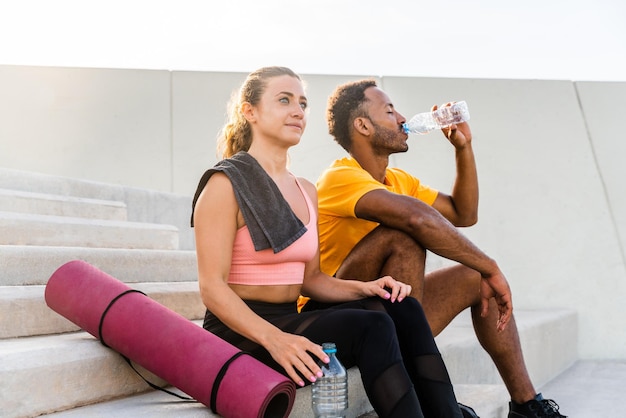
{"left": 0, "top": 0, "right": 626, "bottom": 81}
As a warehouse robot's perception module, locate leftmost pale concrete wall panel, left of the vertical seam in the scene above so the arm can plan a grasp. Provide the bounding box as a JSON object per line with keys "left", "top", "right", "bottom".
{"left": 0, "top": 66, "right": 172, "bottom": 191}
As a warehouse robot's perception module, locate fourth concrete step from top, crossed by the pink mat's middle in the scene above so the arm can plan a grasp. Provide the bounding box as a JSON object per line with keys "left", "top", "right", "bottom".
{"left": 0, "top": 281, "right": 205, "bottom": 338}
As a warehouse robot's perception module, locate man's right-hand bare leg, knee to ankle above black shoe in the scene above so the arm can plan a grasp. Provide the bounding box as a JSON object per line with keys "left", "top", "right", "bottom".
{"left": 421, "top": 265, "right": 536, "bottom": 403}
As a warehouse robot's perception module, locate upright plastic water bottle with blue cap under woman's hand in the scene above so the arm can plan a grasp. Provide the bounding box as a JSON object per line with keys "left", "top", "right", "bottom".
{"left": 311, "top": 343, "right": 348, "bottom": 418}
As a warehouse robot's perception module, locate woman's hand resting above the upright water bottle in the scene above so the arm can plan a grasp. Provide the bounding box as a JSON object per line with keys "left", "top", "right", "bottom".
{"left": 264, "top": 331, "right": 330, "bottom": 386}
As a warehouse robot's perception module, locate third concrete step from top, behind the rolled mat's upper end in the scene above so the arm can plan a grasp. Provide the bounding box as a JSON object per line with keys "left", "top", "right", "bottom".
{"left": 0, "top": 245, "right": 198, "bottom": 286}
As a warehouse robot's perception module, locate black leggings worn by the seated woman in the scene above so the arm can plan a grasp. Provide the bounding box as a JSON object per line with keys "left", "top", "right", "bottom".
{"left": 204, "top": 298, "right": 462, "bottom": 418}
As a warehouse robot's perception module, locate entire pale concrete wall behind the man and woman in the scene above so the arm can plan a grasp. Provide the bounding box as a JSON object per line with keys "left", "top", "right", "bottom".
{"left": 0, "top": 66, "right": 626, "bottom": 359}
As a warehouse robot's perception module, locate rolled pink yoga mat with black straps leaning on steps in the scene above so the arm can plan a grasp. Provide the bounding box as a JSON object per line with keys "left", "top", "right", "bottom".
{"left": 45, "top": 260, "right": 296, "bottom": 418}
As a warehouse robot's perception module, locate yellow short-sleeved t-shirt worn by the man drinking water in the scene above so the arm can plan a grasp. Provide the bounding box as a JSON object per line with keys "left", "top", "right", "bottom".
{"left": 316, "top": 157, "right": 438, "bottom": 276}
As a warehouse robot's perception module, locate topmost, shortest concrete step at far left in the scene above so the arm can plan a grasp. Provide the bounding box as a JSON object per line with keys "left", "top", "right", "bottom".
{"left": 0, "top": 189, "right": 127, "bottom": 221}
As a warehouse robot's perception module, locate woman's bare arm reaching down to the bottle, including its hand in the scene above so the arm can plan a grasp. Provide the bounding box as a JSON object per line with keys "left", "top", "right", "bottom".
{"left": 194, "top": 173, "right": 327, "bottom": 386}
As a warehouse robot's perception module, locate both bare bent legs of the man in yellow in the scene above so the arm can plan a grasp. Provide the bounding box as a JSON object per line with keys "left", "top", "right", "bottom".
{"left": 336, "top": 227, "right": 536, "bottom": 403}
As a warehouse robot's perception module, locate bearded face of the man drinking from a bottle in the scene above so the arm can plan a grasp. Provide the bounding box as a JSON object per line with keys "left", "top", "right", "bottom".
{"left": 365, "top": 87, "right": 409, "bottom": 154}
